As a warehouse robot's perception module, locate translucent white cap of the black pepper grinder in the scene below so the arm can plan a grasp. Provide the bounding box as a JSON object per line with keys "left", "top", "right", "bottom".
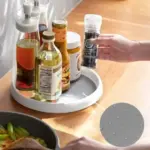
{"left": 84, "top": 14, "right": 102, "bottom": 33}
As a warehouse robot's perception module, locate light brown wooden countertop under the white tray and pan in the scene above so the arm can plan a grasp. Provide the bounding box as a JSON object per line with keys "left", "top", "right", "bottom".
{"left": 0, "top": 0, "right": 150, "bottom": 146}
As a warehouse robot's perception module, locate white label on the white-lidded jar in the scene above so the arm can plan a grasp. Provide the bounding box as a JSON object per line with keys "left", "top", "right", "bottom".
{"left": 70, "top": 52, "right": 81, "bottom": 81}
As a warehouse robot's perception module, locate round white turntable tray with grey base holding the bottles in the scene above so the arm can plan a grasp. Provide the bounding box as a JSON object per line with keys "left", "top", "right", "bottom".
{"left": 11, "top": 67, "right": 103, "bottom": 113}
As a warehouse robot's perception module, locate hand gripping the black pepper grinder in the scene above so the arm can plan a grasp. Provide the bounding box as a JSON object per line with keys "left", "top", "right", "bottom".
{"left": 92, "top": 34, "right": 136, "bottom": 62}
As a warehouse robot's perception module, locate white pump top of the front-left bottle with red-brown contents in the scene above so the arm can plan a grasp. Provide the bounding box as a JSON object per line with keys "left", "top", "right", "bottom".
{"left": 16, "top": 2, "right": 38, "bottom": 33}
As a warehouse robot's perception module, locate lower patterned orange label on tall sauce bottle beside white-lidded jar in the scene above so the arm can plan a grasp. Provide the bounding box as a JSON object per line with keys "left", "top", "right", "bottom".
{"left": 62, "top": 64, "right": 70, "bottom": 91}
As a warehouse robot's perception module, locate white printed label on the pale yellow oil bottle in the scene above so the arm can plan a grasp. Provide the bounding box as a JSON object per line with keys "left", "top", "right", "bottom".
{"left": 39, "top": 64, "right": 62, "bottom": 100}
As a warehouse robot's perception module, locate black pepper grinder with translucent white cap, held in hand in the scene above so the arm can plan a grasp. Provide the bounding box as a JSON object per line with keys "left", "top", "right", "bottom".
{"left": 82, "top": 14, "right": 102, "bottom": 68}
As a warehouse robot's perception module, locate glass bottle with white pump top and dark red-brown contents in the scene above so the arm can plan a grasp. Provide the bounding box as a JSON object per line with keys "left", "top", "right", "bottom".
{"left": 16, "top": 2, "right": 39, "bottom": 96}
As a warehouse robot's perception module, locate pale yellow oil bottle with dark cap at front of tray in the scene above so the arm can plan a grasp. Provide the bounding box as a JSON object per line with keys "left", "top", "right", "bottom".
{"left": 36, "top": 31, "right": 62, "bottom": 102}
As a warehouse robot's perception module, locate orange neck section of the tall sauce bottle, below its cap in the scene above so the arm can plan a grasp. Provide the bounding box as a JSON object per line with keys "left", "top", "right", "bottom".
{"left": 53, "top": 27, "right": 67, "bottom": 42}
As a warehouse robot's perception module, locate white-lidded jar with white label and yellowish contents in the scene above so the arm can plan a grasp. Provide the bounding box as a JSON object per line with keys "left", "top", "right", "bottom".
{"left": 67, "top": 32, "right": 81, "bottom": 81}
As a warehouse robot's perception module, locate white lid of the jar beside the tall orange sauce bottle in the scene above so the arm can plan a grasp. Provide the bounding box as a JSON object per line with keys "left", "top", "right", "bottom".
{"left": 67, "top": 31, "right": 81, "bottom": 50}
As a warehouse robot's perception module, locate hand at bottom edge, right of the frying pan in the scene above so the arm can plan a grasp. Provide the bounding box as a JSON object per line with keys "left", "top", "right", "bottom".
{"left": 61, "top": 137, "right": 115, "bottom": 150}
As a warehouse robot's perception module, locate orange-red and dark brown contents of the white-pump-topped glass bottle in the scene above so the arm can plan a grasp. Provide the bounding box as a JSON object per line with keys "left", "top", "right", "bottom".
{"left": 16, "top": 39, "right": 39, "bottom": 91}
